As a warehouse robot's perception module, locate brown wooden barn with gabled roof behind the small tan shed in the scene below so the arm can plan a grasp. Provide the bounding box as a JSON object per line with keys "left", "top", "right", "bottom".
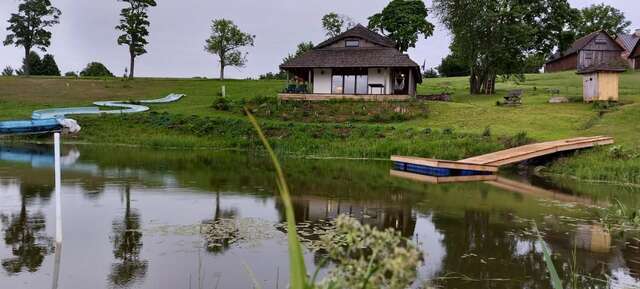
{"left": 544, "top": 31, "right": 625, "bottom": 72}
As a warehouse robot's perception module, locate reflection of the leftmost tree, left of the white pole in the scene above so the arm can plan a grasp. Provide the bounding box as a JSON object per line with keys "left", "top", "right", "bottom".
{"left": 0, "top": 184, "right": 54, "bottom": 274}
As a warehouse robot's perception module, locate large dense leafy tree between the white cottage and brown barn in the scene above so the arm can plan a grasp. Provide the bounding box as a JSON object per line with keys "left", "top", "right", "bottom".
{"left": 434, "top": 0, "right": 573, "bottom": 94}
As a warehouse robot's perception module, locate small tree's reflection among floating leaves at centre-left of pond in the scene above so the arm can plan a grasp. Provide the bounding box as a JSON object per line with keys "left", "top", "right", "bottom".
{"left": 202, "top": 191, "right": 238, "bottom": 254}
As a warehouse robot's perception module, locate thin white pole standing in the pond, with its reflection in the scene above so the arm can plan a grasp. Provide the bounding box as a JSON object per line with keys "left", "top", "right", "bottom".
{"left": 51, "top": 133, "right": 62, "bottom": 289}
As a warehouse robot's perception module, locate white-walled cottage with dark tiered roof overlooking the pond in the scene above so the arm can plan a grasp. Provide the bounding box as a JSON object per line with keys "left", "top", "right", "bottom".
{"left": 280, "top": 25, "right": 422, "bottom": 100}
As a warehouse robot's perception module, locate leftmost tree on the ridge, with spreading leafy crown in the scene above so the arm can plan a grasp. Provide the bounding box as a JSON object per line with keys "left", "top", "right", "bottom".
{"left": 3, "top": 0, "right": 62, "bottom": 75}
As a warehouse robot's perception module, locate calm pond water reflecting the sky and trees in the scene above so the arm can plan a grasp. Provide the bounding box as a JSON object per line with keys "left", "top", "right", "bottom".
{"left": 0, "top": 145, "right": 640, "bottom": 289}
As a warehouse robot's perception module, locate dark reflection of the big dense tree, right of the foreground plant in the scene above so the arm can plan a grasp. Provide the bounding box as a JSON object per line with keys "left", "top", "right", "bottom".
{"left": 427, "top": 211, "right": 550, "bottom": 288}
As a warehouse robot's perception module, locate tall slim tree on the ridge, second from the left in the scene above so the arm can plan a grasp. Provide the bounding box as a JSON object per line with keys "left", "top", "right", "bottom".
{"left": 116, "top": 0, "right": 157, "bottom": 78}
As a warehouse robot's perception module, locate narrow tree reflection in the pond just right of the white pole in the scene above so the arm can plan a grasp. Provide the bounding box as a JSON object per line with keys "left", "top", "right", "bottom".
{"left": 109, "top": 184, "right": 148, "bottom": 287}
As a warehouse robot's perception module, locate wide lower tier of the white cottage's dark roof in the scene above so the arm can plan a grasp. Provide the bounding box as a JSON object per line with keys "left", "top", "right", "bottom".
{"left": 280, "top": 47, "right": 420, "bottom": 69}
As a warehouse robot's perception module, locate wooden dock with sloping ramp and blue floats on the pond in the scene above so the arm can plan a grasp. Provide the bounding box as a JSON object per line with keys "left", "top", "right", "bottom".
{"left": 391, "top": 136, "right": 614, "bottom": 178}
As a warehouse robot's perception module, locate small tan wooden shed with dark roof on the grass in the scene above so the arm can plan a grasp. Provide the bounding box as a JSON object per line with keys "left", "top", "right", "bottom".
{"left": 578, "top": 63, "right": 626, "bottom": 102}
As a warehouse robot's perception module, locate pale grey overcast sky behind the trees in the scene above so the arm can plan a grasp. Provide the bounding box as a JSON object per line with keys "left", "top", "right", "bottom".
{"left": 0, "top": 0, "right": 640, "bottom": 78}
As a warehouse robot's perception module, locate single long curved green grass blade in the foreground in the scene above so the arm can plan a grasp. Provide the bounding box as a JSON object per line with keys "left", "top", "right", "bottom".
{"left": 245, "top": 108, "right": 310, "bottom": 289}
